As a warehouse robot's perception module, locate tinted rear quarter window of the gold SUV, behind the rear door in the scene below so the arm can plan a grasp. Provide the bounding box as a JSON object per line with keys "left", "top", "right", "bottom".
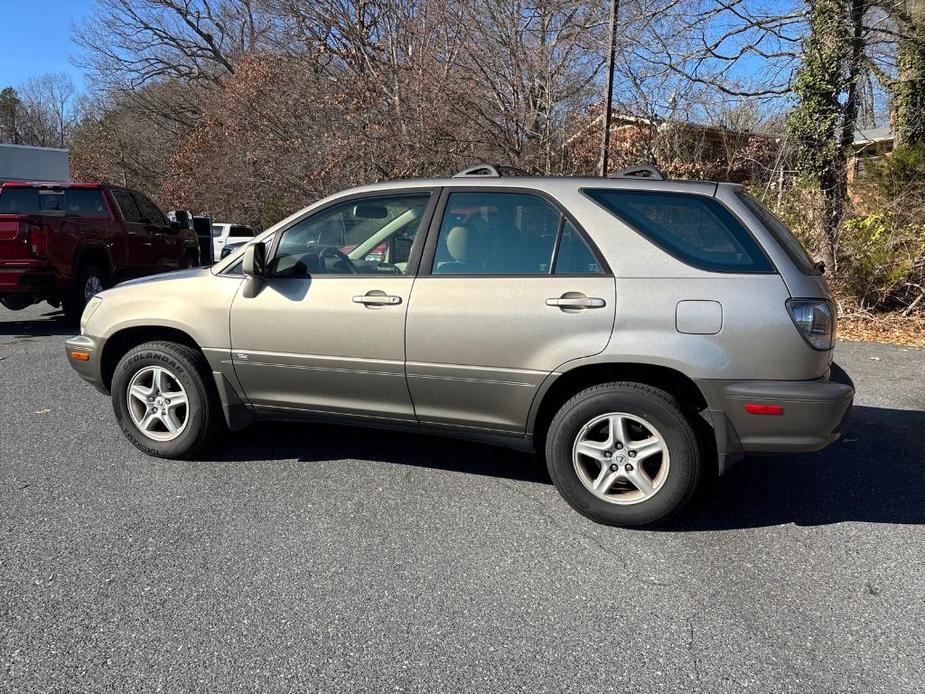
{"left": 583, "top": 188, "right": 774, "bottom": 273}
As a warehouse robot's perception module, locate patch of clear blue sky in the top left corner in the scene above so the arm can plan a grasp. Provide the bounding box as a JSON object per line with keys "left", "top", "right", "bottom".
{"left": 0, "top": 0, "right": 94, "bottom": 89}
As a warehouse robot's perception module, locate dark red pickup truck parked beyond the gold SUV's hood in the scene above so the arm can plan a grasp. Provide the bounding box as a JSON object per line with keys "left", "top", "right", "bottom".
{"left": 0, "top": 183, "right": 199, "bottom": 320}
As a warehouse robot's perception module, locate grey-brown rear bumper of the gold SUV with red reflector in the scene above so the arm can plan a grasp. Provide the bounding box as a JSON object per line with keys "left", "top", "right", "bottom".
{"left": 697, "top": 364, "right": 854, "bottom": 471}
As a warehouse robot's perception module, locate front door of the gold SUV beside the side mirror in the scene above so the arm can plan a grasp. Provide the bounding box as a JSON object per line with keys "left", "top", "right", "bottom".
{"left": 231, "top": 189, "right": 435, "bottom": 420}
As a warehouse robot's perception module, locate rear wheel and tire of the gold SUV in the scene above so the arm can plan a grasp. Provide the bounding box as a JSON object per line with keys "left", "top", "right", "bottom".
{"left": 546, "top": 382, "right": 704, "bottom": 527}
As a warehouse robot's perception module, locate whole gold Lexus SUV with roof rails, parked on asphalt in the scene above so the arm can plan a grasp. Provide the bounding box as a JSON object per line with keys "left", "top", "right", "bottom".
{"left": 67, "top": 165, "right": 854, "bottom": 525}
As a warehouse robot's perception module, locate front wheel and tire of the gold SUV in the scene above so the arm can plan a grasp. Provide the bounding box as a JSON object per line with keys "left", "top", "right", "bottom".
{"left": 112, "top": 342, "right": 225, "bottom": 459}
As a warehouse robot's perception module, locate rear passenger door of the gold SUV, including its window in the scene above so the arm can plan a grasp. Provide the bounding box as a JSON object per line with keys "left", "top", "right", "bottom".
{"left": 406, "top": 187, "right": 615, "bottom": 431}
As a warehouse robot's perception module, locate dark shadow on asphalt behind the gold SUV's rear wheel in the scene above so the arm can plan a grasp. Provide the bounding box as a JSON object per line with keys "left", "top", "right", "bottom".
{"left": 665, "top": 407, "right": 925, "bottom": 530}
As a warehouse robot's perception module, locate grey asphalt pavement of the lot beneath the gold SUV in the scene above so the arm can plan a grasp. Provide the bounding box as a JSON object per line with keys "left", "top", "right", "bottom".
{"left": 0, "top": 304, "right": 925, "bottom": 694}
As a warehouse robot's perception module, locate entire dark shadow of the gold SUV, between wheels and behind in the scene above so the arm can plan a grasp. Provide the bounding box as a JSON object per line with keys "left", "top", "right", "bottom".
{"left": 208, "top": 407, "right": 925, "bottom": 532}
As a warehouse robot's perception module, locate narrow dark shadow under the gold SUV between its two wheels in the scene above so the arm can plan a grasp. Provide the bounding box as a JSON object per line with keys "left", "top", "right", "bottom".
{"left": 206, "top": 422, "right": 550, "bottom": 484}
